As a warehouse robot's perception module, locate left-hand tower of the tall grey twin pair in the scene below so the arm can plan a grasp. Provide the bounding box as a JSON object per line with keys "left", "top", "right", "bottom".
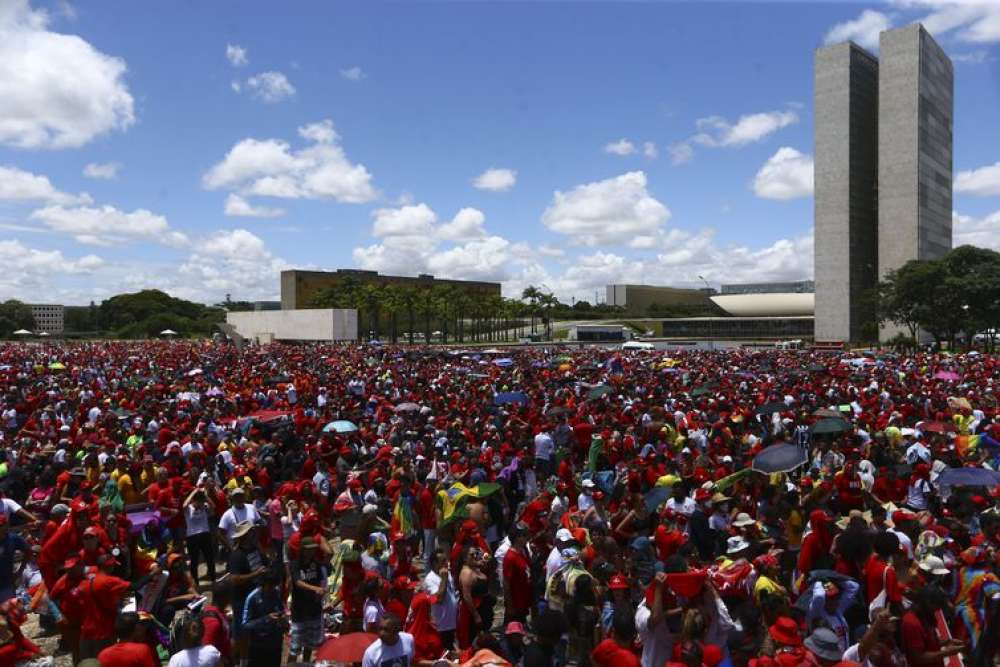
{"left": 813, "top": 43, "right": 879, "bottom": 341}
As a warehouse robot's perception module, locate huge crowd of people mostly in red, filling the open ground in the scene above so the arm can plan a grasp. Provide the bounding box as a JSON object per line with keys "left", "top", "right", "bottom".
{"left": 0, "top": 341, "right": 1000, "bottom": 667}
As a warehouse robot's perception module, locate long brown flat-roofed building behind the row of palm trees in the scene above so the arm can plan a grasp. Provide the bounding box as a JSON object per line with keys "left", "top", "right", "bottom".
{"left": 281, "top": 269, "right": 500, "bottom": 310}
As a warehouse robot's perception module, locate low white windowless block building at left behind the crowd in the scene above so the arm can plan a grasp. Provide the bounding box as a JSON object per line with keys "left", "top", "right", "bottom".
{"left": 226, "top": 308, "right": 358, "bottom": 343}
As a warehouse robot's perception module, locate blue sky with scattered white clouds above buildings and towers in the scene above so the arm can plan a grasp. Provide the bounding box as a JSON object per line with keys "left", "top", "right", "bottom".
{"left": 0, "top": 0, "right": 1000, "bottom": 305}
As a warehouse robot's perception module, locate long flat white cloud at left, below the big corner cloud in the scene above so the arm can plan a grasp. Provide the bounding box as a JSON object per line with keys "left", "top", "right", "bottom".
{"left": 30, "top": 205, "right": 188, "bottom": 247}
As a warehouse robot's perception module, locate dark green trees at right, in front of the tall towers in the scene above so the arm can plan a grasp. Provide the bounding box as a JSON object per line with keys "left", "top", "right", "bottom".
{"left": 869, "top": 245, "right": 1000, "bottom": 352}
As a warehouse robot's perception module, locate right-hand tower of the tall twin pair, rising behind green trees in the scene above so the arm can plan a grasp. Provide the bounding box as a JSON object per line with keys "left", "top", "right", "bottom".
{"left": 878, "top": 24, "right": 954, "bottom": 277}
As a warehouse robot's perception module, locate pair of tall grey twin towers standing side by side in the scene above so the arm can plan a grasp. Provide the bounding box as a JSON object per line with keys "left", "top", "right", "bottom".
{"left": 814, "top": 24, "right": 954, "bottom": 342}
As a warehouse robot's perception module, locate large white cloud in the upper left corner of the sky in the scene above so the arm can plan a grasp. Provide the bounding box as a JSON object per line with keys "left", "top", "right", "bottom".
{"left": 0, "top": 0, "right": 135, "bottom": 148}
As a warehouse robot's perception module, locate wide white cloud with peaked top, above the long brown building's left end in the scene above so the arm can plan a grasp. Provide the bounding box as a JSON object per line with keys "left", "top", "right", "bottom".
{"left": 202, "top": 120, "right": 377, "bottom": 204}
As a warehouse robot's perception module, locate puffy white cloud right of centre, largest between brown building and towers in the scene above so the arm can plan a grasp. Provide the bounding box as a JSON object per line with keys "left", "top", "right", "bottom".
{"left": 542, "top": 171, "right": 670, "bottom": 246}
